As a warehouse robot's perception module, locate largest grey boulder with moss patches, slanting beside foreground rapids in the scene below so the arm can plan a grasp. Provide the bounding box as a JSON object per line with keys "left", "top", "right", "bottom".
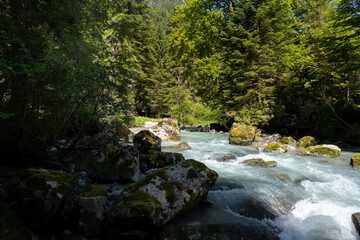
{"left": 107, "top": 160, "right": 218, "bottom": 235}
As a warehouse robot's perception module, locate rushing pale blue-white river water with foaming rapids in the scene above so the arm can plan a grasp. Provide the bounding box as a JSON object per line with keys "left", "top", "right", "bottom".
{"left": 164, "top": 132, "right": 360, "bottom": 240}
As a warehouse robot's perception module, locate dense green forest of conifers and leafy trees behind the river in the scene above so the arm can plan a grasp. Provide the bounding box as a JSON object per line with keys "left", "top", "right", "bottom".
{"left": 0, "top": 0, "right": 360, "bottom": 162}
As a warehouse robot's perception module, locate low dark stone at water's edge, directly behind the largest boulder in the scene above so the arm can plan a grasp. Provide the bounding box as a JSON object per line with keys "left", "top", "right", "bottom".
{"left": 140, "top": 150, "right": 185, "bottom": 172}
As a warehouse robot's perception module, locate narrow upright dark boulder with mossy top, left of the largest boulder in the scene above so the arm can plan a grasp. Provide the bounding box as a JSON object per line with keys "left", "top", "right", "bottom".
{"left": 79, "top": 185, "right": 108, "bottom": 237}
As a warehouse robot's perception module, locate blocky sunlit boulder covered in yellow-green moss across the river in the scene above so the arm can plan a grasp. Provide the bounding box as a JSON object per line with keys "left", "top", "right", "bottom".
{"left": 229, "top": 123, "right": 256, "bottom": 146}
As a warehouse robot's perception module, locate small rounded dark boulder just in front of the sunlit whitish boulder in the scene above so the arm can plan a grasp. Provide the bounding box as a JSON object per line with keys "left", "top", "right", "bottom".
{"left": 134, "top": 130, "right": 162, "bottom": 153}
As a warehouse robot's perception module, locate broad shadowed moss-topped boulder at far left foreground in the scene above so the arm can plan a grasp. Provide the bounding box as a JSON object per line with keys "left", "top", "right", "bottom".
{"left": 7, "top": 169, "right": 77, "bottom": 227}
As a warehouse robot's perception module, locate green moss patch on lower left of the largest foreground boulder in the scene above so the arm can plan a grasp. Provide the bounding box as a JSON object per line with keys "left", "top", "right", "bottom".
{"left": 124, "top": 190, "right": 160, "bottom": 216}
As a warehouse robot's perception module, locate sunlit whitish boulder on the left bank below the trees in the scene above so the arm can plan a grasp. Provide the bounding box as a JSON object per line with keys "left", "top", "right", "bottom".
{"left": 151, "top": 118, "right": 181, "bottom": 141}
